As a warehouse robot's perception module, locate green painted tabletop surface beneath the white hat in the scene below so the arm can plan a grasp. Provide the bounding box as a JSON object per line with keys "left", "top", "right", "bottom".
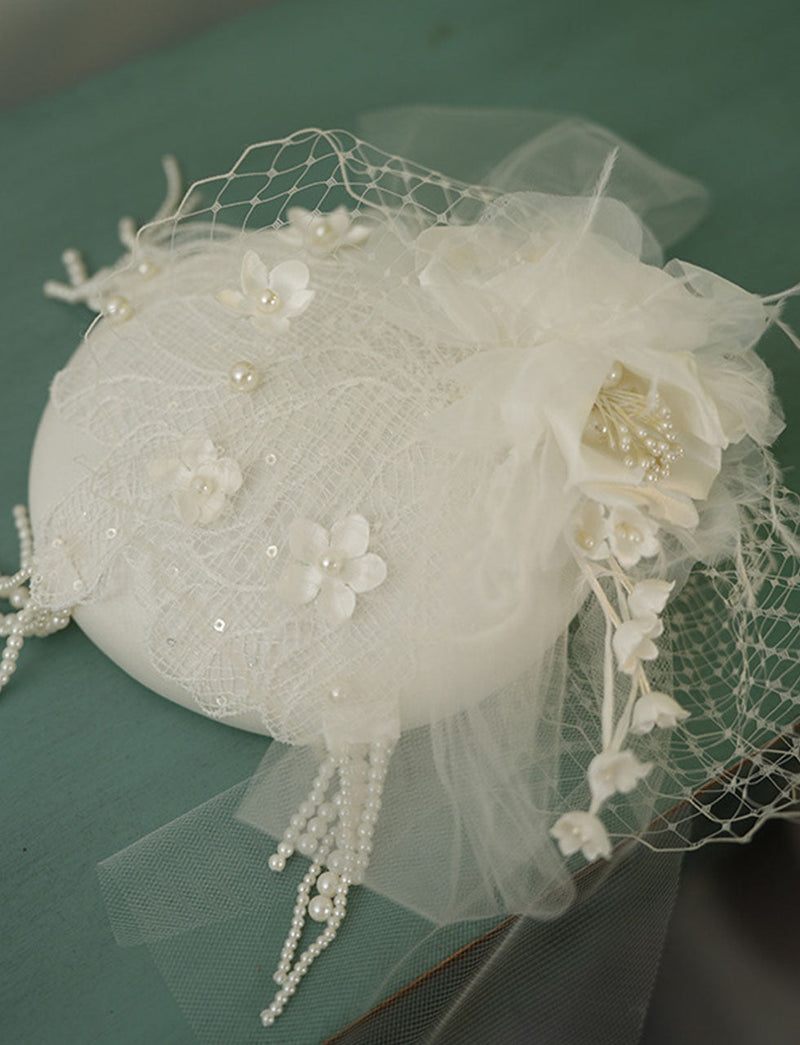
{"left": 0, "top": 0, "right": 800, "bottom": 1045}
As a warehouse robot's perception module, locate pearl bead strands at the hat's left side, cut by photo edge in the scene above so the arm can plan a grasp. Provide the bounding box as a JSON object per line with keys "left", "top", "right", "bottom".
{"left": 0, "top": 505, "right": 70, "bottom": 690}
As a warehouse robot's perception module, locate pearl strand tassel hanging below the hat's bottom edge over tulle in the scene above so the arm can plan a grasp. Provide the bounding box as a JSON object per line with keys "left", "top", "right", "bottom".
{"left": 259, "top": 740, "right": 394, "bottom": 1027}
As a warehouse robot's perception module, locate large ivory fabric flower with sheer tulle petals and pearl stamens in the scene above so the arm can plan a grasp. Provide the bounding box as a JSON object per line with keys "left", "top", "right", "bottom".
{"left": 419, "top": 193, "right": 778, "bottom": 528}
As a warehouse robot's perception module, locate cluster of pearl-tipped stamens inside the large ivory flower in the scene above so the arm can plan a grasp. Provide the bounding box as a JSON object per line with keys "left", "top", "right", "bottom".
{"left": 584, "top": 363, "right": 683, "bottom": 483}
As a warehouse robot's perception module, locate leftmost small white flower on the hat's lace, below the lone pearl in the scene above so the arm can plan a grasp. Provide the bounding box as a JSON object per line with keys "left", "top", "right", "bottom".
{"left": 147, "top": 436, "right": 242, "bottom": 525}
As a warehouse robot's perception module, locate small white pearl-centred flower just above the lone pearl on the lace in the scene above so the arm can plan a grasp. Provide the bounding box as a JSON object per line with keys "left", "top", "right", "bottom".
{"left": 216, "top": 251, "right": 314, "bottom": 333}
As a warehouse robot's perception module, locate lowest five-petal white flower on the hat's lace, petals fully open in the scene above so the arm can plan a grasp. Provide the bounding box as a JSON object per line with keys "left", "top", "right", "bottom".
{"left": 278, "top": 515, "right": 386, "bottom": 624}
